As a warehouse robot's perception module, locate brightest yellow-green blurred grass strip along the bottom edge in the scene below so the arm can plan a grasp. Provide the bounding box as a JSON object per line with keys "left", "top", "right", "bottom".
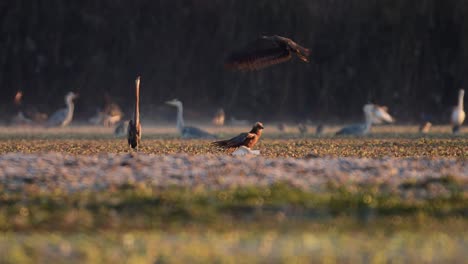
{"left": 0, "top": 227, "right": 468, "bottom": 264}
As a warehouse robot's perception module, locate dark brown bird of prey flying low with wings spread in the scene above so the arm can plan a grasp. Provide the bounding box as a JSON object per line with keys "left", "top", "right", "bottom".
{"left": 225, "top": 35, "right": 310, "bottom": 71}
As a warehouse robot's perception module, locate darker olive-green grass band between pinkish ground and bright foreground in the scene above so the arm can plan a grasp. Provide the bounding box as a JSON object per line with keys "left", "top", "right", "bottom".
{"left": 0, "top": 182, "right": 468, "bottom": 231}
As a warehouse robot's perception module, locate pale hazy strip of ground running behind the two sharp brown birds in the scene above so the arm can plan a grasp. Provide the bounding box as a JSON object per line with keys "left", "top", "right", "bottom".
{"left": 0, "top": 122, "right": 468, "bottom": 139}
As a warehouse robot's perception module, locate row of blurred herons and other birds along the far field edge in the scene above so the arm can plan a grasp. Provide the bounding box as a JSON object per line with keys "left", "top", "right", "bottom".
{"left": 12, "top": 89, "right": 466, "bottom": 138}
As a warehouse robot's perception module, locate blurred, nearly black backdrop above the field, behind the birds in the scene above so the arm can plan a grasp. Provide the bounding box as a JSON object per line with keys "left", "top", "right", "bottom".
{"left": 0, "top": 0, "right": 468, "bottom": 121}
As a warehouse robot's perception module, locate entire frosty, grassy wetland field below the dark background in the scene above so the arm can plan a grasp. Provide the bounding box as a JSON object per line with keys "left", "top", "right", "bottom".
{"left": 0, "top": 124, "right": 468, "bottom": 263}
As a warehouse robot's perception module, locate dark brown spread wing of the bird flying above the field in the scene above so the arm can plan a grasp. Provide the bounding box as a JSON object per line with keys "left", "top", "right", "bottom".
{"left": 225, "top": 38, "right": 291, "bottom": 70}
